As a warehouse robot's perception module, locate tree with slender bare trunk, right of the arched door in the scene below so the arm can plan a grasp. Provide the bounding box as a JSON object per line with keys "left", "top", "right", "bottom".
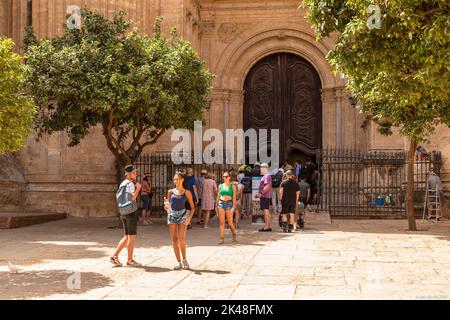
{"left": 303, "top": 0, "right": 450, "bottom": 230}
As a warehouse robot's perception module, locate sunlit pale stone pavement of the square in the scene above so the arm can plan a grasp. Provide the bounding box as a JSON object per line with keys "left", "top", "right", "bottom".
{"left": 0, "top": 218, "right": 450, "bottom": 300}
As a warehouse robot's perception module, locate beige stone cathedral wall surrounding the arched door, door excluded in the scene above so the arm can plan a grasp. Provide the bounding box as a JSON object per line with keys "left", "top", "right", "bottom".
{"left": 0, "top": 0, "right": 450, "bottom": 216}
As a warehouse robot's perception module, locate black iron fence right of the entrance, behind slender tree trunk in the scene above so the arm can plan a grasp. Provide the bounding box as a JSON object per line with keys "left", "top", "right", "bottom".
{"left": 318, "top": 149, "right": 441, "bottom": 217}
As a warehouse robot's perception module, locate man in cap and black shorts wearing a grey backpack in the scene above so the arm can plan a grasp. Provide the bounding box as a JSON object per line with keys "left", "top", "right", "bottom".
{"left": 110, "top": 165, "right": 141, "bottom": 267}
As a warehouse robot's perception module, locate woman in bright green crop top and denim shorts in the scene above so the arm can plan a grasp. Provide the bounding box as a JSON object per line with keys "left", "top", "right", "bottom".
{"left": 216, "top": 172, "right": 237, "bottom": 244}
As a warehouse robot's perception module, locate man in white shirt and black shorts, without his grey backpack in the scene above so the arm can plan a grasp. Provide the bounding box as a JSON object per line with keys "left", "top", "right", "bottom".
{"left": 110, "top": 165, "right": 141, "bottom": 267}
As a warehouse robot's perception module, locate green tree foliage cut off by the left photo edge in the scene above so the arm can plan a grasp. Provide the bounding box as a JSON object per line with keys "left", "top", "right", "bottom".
{"left": 0, "top": 38, "right": 36, "bottom": 156}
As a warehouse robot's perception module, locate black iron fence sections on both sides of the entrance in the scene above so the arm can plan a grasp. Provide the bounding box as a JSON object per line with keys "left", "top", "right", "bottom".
{"left": 135, "top": 149, "right": 442, "bottom": 217}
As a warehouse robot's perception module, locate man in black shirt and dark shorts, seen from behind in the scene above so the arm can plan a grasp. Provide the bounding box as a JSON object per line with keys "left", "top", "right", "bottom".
{"left": 279, "top": 170, "right": 300, "bottom": 232}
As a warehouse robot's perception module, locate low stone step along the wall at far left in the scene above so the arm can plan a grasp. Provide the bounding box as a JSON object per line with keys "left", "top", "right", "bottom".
{"left": 0, "top": 212, "right": 67, "bottom": 229}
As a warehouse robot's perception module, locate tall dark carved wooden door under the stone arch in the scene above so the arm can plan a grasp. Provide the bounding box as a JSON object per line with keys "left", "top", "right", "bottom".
{"left": 244, "top": 53, "right": 322, "bottom": 161}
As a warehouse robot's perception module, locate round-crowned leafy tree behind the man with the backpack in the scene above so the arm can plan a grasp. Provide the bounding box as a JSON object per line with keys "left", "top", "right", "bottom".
{"left": 25, "top": 9, "right": 212, "bottom": 175}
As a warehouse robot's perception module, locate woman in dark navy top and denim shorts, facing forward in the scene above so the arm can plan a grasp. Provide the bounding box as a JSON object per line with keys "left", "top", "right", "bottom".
{"left": 164, "top": 172, "right": 195, "bottom": 270}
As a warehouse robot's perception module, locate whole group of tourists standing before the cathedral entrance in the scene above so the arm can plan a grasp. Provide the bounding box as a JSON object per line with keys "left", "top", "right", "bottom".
{"left": 110, "top": 160, "right": 317, "bottom": 270}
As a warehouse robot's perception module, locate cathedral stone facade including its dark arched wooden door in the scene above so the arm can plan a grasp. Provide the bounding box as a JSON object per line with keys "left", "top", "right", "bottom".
{"left": 0, "top": 0, "right": 450, "bottom": 216}
